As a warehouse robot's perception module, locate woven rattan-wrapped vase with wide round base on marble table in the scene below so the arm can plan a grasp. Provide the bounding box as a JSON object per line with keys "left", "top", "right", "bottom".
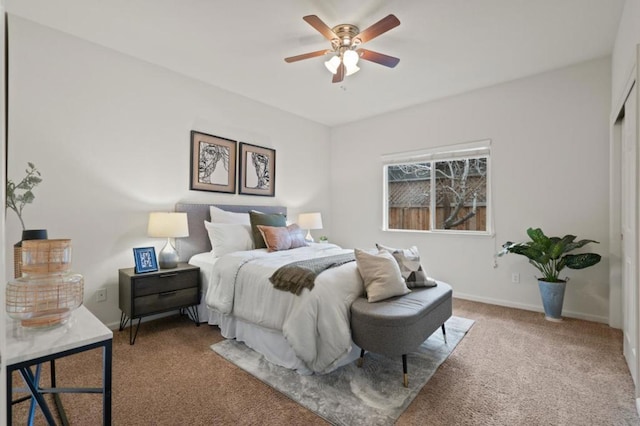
{"left": 6, "top": 239, "right": 84, "bottom": 328}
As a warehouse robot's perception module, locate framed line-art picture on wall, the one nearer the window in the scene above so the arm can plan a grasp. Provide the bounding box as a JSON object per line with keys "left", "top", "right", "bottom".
{"left": 238, "top": 142, "right": 276, "bottom": 197}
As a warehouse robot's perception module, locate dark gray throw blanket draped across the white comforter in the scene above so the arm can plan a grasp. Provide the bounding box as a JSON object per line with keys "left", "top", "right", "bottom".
{"left": 269, "top": 253, "right": 356, "bottom": 295}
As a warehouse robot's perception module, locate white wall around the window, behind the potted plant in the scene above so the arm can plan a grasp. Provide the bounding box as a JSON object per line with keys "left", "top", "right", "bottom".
{"left": 330, "top": 58, "right": 611, "bottom": 322}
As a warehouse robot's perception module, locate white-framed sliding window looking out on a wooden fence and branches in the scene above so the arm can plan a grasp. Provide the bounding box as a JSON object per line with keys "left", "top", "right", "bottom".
{"left": 383, "top": 140, "right": 491, "bottom": 234}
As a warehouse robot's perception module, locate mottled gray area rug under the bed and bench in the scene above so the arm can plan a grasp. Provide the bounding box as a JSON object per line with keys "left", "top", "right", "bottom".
{"left": 211, "top": 316, "right": 473, "bottom": 426}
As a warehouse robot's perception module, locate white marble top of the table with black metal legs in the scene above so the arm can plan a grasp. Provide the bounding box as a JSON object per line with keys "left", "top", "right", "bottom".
{"left": 3, "top": 305, "right": 113, "bottom": 365}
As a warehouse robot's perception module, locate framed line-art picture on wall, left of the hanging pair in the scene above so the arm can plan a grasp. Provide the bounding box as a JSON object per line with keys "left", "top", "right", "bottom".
{"left": 189, "top": 130, "right": 238, "bottom": 194}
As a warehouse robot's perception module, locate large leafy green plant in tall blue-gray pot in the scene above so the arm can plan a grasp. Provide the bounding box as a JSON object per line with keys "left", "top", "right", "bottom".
{"left": 498, "top": 228, "right": 601, "bottom": 321}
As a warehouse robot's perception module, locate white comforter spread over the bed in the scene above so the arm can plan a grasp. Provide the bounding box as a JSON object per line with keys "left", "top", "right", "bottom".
{"left": 206, "top": 244, "right": 364, "bottom": 373}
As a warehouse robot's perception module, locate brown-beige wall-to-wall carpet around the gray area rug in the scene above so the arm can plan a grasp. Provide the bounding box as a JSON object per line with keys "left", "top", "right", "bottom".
{"left": 14, "top": 300, "right": 640, "bottom": 425}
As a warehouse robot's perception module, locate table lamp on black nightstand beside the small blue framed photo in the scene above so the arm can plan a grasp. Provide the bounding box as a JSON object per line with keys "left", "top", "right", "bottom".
{"left": 147, "top": 212, "right": 189, "bottom": 269}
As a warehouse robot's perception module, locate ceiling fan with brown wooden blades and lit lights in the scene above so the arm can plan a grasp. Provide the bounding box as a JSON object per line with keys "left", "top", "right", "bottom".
{"left": 284, "top": 15, "right": 400, "bottom": 83}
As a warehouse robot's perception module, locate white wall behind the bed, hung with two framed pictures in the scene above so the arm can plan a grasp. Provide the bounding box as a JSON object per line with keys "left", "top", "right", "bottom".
{"left": 6, "top": 16, "right": 331, "bottom": 324}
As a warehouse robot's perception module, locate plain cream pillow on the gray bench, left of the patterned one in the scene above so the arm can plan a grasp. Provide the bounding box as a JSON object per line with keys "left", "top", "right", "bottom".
{"left": 354, "top": 249, "right": 411, "bottom": 302}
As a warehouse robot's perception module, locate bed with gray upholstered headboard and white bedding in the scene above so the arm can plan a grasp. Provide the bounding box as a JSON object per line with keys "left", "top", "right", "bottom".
{"left": 176, "top": 203, "right": 364, "bottom": 374}
